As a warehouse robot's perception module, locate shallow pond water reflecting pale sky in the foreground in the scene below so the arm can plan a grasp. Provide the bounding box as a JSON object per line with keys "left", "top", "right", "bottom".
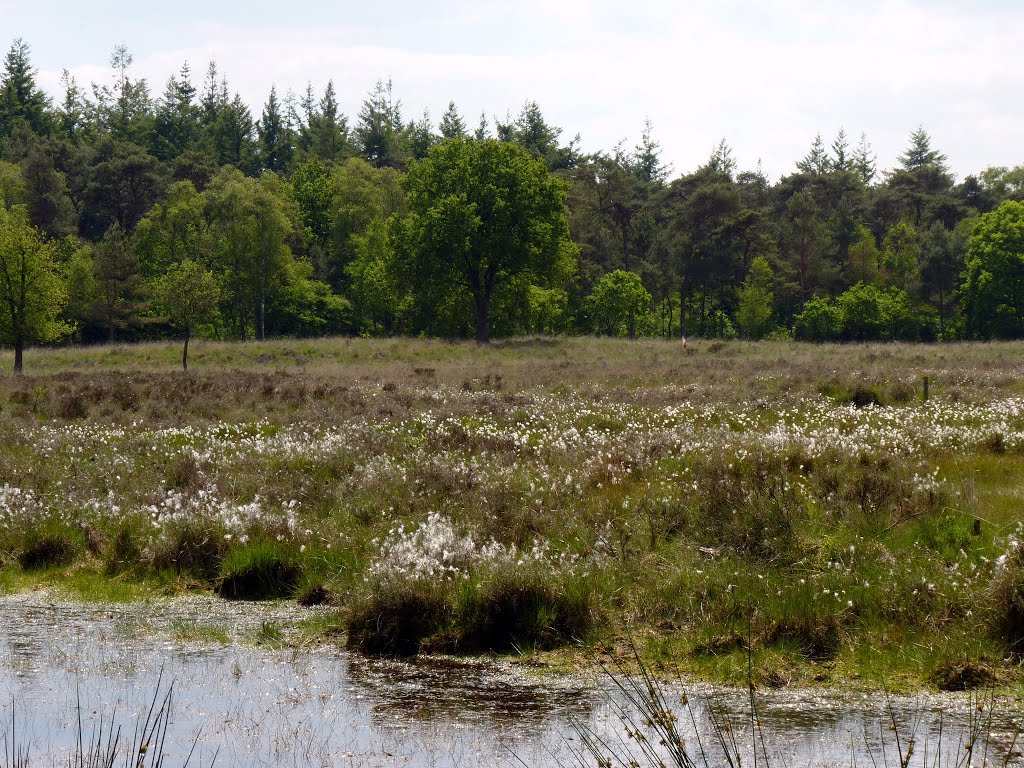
{"left": 0, "top": 596, "right": 1018, "bottom": 766}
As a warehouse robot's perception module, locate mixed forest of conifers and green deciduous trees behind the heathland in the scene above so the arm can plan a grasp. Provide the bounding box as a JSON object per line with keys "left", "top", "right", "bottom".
{"left": 0, "top": 40, "right": 1024, "bottom": 368}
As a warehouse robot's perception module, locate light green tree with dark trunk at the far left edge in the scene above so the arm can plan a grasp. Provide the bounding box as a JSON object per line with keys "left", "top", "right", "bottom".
{"left": 0, "top": 207, "right": 72, "bottom": 373}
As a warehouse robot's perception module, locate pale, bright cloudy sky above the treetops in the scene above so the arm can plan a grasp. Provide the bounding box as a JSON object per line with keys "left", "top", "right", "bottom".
{"left": 0, "top": 0, "right": 1024, "bottom": 181}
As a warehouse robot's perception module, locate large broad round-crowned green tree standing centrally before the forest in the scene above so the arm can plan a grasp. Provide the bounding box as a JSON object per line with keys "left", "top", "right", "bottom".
{"left": 398, "top": 138, "right": 575, "bottom": 343}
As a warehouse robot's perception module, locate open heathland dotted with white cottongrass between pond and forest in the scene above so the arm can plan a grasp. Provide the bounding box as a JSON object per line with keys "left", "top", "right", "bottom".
{"left": 0, "top": 338, "right": 1024, "bottom": 689}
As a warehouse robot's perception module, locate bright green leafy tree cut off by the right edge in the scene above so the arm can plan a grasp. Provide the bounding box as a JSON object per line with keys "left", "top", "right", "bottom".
{"left": 963, "top": 200, "right": 1024, "bottom": 339}
